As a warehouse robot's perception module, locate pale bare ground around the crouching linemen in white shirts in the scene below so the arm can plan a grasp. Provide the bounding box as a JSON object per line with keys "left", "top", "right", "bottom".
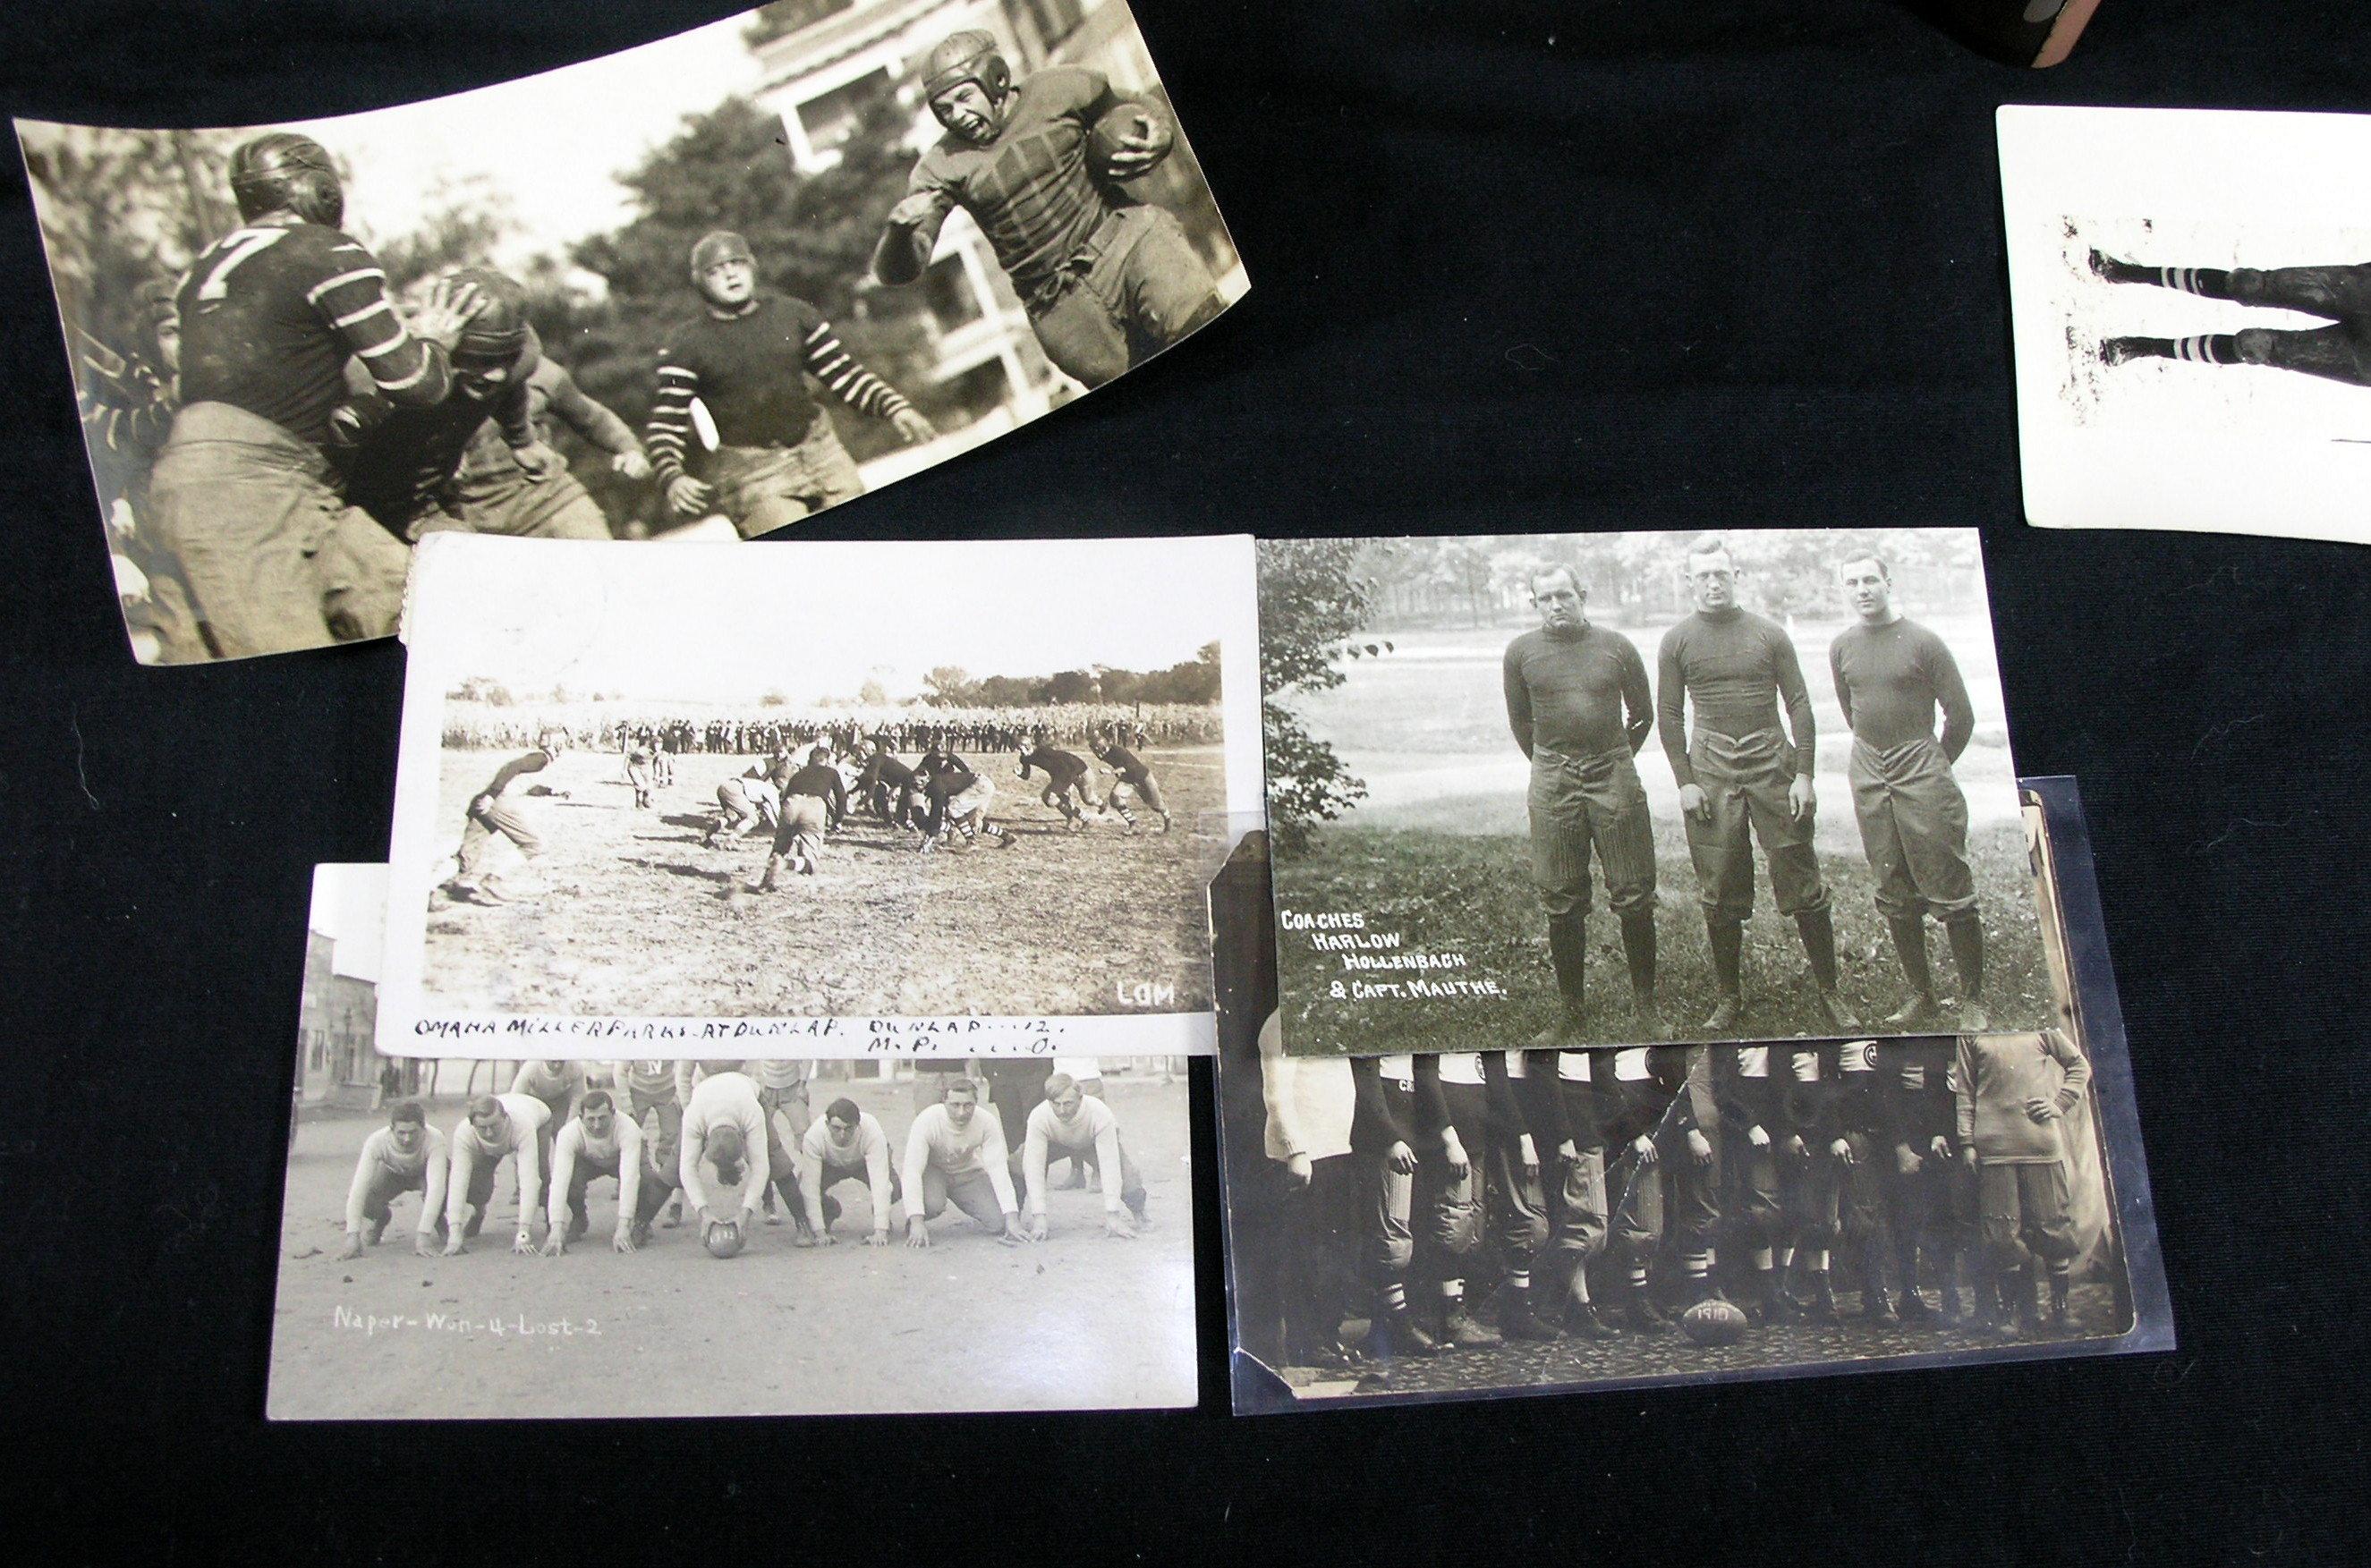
{"left": 268, "top": 1078, "right": 1195, "bottom": 1419}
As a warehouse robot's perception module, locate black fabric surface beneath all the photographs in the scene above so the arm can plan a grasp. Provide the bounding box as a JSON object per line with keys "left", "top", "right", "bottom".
{"left": 0, "top": 0, "right": 2371, "bottom": 1564}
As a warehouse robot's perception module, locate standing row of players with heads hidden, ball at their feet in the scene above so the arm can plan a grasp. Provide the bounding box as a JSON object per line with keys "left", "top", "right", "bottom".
{"left": 1262, "top": 1032, "right": 2105, "bottom": 1364}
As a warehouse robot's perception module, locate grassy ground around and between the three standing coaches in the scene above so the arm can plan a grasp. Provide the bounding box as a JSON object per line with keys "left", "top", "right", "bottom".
{"left": 1276, "top": 623, "right": 2051, "bottom": 1054}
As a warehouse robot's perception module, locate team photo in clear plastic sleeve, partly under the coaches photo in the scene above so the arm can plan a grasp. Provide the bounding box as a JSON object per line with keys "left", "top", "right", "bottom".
{"left": 1214, "top": 805, "right": 2170, "bottom": 1410}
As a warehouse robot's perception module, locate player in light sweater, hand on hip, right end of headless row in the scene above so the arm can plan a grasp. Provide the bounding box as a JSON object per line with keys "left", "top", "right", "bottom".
{"left": 1954, "top": 1028, "right": 2091, "bottom": 1331}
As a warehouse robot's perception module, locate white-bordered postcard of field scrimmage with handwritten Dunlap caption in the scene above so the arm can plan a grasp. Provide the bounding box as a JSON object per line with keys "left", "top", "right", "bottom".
{"left": 379, "top": 535, "right": 1262, "bottom": 1059}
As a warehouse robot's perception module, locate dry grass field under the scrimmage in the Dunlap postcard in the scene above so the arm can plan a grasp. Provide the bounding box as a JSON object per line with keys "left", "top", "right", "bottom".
{"left": 424, "top": 746, "right": 1226, "bottom": 1019}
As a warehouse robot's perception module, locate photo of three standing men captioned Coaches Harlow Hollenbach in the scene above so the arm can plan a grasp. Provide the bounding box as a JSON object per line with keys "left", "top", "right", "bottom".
{"left": 1259, "top": 529, "right": 2051, "bottom": 1056}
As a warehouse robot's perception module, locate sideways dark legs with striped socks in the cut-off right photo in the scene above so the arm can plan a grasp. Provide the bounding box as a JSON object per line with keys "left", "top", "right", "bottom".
{"left": 2091, "top": 251, "right": 2371, "bottom": 386}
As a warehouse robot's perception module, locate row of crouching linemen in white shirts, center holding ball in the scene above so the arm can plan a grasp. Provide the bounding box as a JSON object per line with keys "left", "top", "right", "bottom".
{"left": 342, "top": 1059, "right": 1150, "bottom": 1258}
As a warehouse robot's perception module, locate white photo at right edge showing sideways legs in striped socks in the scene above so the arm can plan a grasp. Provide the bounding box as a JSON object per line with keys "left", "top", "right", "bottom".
{"left": 1999, "top": 105, "right": 2371, "bottom": 542}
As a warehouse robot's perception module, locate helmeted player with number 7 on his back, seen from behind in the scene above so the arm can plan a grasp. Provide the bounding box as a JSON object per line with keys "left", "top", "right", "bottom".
{"left": 149, "top": 131, "right": 481, "bottom": 658}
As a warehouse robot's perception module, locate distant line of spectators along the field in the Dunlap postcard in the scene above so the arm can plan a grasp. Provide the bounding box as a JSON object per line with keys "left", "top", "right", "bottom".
{"left": 444, "top": 703, "right": 1223, "bottom": 756}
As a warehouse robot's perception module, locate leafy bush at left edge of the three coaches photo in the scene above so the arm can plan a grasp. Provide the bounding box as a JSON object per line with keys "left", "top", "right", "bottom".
{"left": 1252, "top": 540, "right": 1389, "bottom": 851}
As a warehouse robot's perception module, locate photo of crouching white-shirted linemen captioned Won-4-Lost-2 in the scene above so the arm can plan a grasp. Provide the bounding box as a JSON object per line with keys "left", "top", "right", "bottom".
{"left": 268, "top": 865, "right": 1195, "bottom": 1421}
